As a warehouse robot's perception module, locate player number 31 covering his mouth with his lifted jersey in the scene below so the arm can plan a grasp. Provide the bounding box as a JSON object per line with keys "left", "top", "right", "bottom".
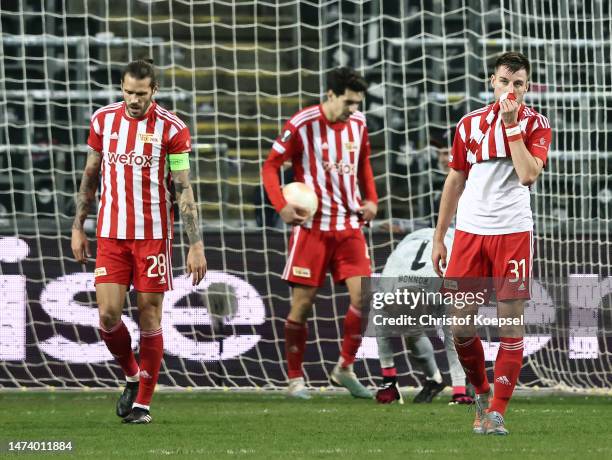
{"left": 432, "top": 52, "right": 552, "bottom": 435}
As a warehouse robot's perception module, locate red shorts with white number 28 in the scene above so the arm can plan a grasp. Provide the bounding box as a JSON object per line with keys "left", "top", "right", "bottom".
{"left": 94, "top": 237, "right": 172, "bottom": 292}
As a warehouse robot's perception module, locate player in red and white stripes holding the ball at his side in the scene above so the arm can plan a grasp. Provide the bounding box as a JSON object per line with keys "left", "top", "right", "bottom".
{"left": 262, "top": 67, "right": 378, "bottom": 399}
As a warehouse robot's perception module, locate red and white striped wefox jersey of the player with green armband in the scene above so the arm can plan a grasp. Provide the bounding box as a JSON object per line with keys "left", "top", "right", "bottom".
{"left": 87, "top": 102, "right": 191, "bottom": 239}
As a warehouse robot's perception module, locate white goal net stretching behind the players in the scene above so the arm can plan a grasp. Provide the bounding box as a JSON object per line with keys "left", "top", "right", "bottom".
{"left": 0, "top": 0, "right": 612, "bottom": 389}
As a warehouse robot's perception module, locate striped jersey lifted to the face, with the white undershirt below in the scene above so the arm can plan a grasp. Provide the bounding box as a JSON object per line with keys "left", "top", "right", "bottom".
{"left": 449, "top": 104, "right": 552, "bottom": 235}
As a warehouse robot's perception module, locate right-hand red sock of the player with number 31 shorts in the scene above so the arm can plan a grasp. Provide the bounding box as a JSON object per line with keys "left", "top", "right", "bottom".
{"left": 489, "top": 337, "right": 523, "bottom": 415}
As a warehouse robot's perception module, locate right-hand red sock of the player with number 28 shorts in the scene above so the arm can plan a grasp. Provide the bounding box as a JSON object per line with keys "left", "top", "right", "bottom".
{"left": 135, "top": 327, "right": 164, "bottom": 406}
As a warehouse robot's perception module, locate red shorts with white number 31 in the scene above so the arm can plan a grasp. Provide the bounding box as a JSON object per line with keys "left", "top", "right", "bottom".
{"left": 444, "top": 230, "right": 533, "bottom": 300}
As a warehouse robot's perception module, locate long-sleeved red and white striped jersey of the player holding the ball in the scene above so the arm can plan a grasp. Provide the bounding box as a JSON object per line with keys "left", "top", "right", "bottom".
{"left": 262, "top": 105, "right": 378, "bottom": 231}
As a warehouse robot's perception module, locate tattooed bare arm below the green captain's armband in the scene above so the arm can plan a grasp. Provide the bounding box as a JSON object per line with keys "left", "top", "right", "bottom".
{"left": 172, "top": 169, "right": 206, "bottom": 286}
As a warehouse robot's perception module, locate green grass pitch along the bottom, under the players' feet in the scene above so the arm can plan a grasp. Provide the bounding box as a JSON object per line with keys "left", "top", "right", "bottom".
{"left": 0, "top": 392, "right": 612, "bottom": 460}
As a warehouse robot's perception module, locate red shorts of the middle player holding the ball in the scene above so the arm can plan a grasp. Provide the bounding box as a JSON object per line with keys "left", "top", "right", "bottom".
{"left": 283, "top": 226, "right": 372, "bottom": 286}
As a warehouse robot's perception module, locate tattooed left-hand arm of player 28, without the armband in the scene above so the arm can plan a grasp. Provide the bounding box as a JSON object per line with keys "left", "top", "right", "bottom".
{"left": 71, "top": 149, "right": 102, "bottom": 264}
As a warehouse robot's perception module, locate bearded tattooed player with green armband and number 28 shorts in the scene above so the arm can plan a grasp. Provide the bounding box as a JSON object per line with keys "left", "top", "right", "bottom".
{"left": 72, "top": 60, "right": 206, "bottom": 423}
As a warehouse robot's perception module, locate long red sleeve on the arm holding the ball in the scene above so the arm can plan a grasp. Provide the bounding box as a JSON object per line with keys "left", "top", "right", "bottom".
{"left": 261, "top": 122, "right": 302, "bottom": 212}
